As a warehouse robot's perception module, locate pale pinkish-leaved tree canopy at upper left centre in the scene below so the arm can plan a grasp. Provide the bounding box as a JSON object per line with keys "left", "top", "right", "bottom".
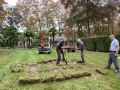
{"left": 17, "top": 0, "right": 63, "bottom": 32}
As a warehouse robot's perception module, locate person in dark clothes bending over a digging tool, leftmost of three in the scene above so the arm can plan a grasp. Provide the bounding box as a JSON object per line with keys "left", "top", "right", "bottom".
{"left": 56, "top": 40, "right": 67, "bottom": 65}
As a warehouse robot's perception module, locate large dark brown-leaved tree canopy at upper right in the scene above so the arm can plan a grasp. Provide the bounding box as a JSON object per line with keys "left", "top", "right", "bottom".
{"left": 61, "top": 0, "right": 118, "bottom": 35}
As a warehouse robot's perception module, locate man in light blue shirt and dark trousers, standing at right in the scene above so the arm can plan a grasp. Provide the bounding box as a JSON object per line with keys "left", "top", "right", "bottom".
{"left": 106, "top": 35, "right": 120, "bottom": 73}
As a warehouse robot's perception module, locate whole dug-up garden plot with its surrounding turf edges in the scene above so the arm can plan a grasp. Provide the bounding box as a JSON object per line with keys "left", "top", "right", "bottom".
{"left": 8, "top": 59, "right": 106, "bottom": 85}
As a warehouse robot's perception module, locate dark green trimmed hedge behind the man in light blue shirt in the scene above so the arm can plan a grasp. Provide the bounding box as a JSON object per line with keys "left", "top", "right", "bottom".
{"left": 83, "top": 37, "right": 111, "bottom": 52}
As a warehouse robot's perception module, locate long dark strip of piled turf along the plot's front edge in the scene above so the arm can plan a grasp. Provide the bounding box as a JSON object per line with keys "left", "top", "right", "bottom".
{"left": 19, "top": 72, "right": 91, "bottom": 85}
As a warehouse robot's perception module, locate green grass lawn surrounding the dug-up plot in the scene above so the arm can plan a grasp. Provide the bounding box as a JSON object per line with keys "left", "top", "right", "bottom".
{"left": 0, "top": 49, "right": 120, "bottom": 90}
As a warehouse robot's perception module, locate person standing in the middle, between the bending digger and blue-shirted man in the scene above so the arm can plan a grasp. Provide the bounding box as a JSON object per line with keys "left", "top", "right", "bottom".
{"left": 77, "top": 39, "right": 85, "bottom": 64}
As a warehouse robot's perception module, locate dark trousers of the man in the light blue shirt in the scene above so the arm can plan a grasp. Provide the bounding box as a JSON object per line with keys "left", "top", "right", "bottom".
{"left": 108, "top": 52, "right": 119, "bottom": 70}
